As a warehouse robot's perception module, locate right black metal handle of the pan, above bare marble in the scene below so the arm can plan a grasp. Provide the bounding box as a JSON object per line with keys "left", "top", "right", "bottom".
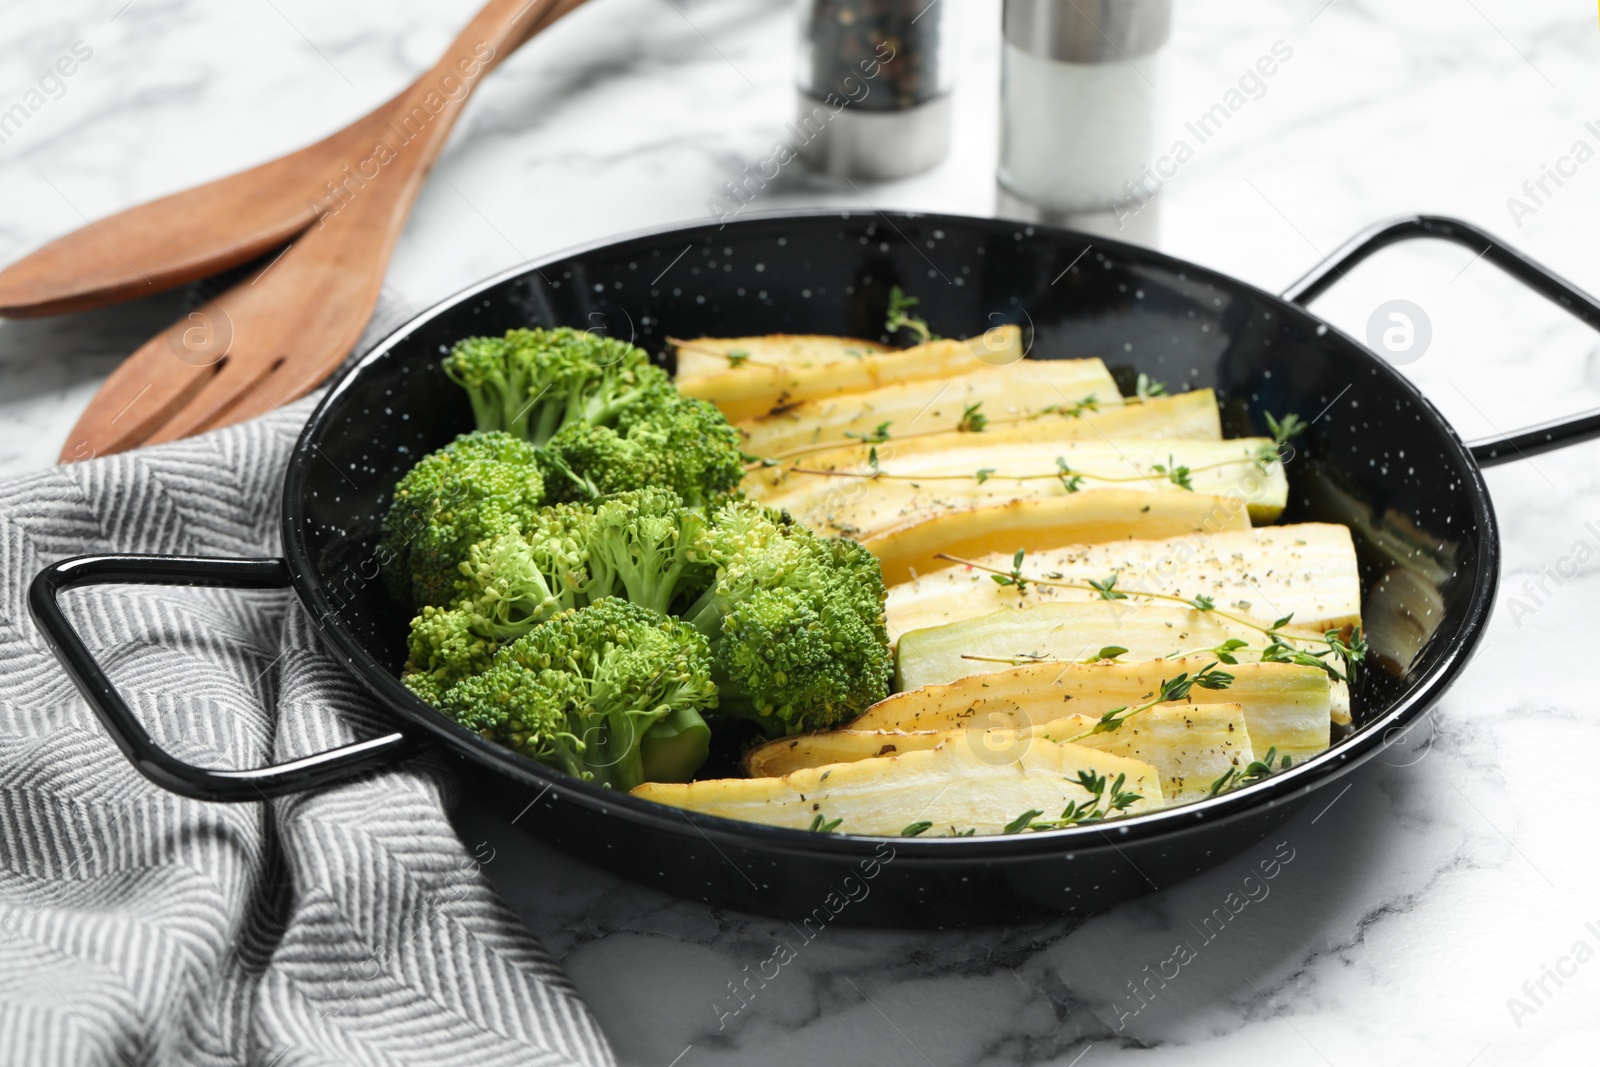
{"left": 1283, "top": 214, "right": 1600, "bottom": 467}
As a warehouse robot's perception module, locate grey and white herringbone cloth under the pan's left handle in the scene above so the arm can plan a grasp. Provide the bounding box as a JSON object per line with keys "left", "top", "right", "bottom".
{"left": 0, "top": 402, "right": 613, "bottom": 1067}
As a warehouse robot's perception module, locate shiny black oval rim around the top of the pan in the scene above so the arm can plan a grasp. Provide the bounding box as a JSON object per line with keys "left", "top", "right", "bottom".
{"left": 280, "top": 208, "right": 1501, "bottom": 864}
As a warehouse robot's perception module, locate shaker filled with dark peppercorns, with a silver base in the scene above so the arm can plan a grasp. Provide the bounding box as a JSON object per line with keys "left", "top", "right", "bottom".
{"left": 790, "top": 0, "right": 955, "bottom": 181}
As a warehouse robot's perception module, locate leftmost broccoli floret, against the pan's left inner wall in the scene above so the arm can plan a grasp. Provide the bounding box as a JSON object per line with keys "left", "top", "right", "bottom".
{"left": 382, "top": 432, "right": 544, "bottom": 606}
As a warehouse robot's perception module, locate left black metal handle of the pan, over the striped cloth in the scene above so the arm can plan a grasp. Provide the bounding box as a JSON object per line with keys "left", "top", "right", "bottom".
{"left": 27, "top": 555, "right": 418, "bottom": 801}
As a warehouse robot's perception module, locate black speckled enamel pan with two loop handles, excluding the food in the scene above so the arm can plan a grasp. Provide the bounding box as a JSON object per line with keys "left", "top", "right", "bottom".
{"left": 30, "top": 213, "right": 1600, "bottom": 925}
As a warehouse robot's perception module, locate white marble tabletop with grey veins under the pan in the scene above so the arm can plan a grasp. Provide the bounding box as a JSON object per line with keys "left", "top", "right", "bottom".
{"left": 0, "top": 0, "right": 1600, "bottom": 1067}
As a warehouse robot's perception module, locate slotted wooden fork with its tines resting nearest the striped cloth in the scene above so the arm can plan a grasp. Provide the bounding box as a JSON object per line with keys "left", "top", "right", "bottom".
{"left": 61, "top": 0, "right": 582, "bottom": 462}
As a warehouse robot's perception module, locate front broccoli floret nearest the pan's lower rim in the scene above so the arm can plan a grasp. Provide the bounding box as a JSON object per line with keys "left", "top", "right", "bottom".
{"left": 440, "top": 597, "right": 717, "bottom": 790}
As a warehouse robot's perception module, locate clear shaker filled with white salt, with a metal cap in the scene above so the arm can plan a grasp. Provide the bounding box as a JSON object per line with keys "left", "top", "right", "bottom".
{"left": 997, "top": 0, "right": 1171, "bottom": 245}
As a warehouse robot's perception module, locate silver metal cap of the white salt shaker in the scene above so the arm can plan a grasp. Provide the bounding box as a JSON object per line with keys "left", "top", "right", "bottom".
{"left": 1005, "top": 0, "right": 1173, "bottom": 62}
